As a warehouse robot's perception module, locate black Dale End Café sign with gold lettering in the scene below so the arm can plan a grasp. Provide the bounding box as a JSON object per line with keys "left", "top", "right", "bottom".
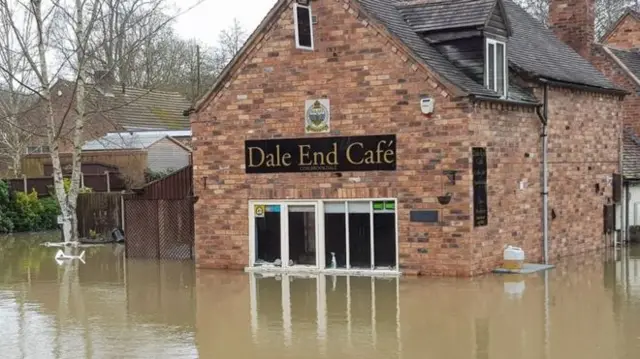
{"left": 245, "top": 135, "right": 396, "bottom": 173}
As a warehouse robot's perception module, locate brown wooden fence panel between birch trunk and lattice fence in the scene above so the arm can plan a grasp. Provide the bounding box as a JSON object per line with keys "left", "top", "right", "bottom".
{"left": 76, "top": 193, "right": 123, "bottom": 238}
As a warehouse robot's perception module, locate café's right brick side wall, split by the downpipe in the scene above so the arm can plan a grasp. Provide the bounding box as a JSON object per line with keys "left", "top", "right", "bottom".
{"left": 470, "top": 88, "right": 620, "bottom": 273}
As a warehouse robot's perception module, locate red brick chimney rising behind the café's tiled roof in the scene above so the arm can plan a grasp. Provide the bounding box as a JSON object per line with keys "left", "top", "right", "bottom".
{"left": 549, "top": 0, "right": 596, "bottom": 59}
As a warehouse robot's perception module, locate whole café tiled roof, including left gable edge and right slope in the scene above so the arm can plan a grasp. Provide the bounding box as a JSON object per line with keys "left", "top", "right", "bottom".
{"left": 196, "top": 0, "right": 625, "bottom": 111}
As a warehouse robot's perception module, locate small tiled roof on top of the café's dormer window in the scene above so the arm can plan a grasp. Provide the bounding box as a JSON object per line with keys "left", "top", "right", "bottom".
{"left": 397, "top": 0, "right": 496, "bottom": 32}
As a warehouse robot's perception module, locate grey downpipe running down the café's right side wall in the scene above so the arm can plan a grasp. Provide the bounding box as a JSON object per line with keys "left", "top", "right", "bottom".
{"left": 536, "top": 83, "right": 549, "bottom": 264}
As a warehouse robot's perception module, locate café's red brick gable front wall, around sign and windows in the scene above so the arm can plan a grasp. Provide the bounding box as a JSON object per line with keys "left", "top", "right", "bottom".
{"left": 192, "top": 1, "right": 470, "bottom": 275}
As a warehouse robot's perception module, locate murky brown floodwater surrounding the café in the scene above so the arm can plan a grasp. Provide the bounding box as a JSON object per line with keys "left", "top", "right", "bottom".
{"left": 0, "top": 234, "right": 640, "bottom": 359}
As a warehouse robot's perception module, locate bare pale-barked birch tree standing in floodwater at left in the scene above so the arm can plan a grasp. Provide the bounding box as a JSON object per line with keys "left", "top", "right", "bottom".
{"left": 0, "top": 0, "right": 200, "bottom": 242}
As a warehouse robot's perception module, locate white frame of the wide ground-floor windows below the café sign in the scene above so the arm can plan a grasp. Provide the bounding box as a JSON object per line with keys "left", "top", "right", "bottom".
{"left": 245, "top": 198, "right": 400, "bottom": 276}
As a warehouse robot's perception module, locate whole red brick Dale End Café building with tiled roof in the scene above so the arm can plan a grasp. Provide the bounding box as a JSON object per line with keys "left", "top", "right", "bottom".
{"left": 191, "top": 0, "right": 625, "bottom": 276}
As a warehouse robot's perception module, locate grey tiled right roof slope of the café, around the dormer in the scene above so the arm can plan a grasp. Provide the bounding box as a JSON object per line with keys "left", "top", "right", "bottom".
{"left": 360, "top": 0, "right": 617, "bottom": 98}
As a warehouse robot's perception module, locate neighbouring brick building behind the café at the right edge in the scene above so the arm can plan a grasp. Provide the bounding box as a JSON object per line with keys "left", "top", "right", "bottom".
{"left": 591, "top": 9, "right": 640, "bottom": 237}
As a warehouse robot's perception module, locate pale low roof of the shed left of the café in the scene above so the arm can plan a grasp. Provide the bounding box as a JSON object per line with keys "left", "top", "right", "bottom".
{"left": 82, "top": 131, "right": 191, "bottom": 151}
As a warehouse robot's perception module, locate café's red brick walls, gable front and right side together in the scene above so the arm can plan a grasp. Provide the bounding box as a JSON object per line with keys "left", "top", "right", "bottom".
{"left": 192, "top": 1, "right": 619, "bottom": 276}
